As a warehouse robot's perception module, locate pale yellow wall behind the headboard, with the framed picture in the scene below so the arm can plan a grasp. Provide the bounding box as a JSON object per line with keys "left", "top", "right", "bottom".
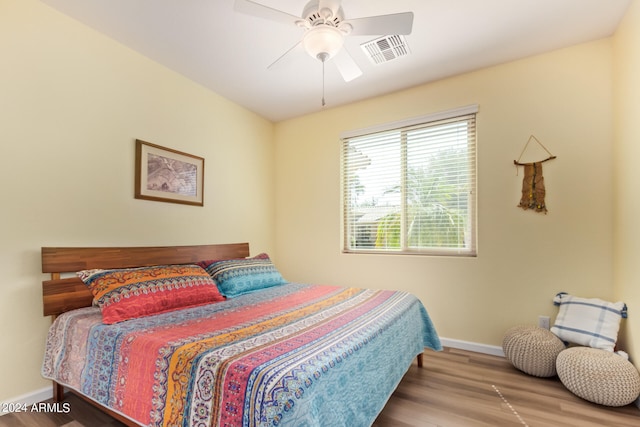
{"left": 0, "top": 0, "right": 274, "bottom": 401}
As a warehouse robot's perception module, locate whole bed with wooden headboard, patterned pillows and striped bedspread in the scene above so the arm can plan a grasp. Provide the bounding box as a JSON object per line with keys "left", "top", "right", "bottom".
{"left": 42, "top": 243, "right": 441, "bottom": 427}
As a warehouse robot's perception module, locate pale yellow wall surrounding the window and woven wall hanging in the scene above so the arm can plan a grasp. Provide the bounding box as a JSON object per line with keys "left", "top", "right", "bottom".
{"left": 276, "top": 39, "right": 613, "bottom": 352}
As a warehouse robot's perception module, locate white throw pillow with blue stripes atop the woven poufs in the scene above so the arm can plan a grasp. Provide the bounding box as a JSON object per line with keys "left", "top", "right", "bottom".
{"left": 551, "top": 292, "right": 627, "bottom": 351}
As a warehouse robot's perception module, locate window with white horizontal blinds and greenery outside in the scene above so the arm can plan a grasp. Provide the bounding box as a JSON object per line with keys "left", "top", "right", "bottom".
{"left": 341, "top": 105, "right": 478, "bottom": 256}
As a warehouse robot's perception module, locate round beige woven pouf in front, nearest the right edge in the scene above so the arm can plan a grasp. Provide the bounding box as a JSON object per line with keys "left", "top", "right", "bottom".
{"left": 556, "top": 347, "right": 640, "bottom": 406}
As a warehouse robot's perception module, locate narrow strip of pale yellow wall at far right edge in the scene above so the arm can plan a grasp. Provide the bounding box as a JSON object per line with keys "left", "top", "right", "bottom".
{"left": 613, "top": 1, "right": 640, "bottom": 366}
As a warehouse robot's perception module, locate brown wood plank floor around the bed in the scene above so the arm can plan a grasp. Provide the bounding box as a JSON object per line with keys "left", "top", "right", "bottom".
{"left": 0, "top": 348, "right": 640, "bottom": 427}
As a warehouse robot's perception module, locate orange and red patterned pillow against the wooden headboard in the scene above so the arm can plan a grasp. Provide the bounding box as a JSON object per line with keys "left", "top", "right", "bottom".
{"left": 77, "top": 265, "right": 224, "bottom": 324}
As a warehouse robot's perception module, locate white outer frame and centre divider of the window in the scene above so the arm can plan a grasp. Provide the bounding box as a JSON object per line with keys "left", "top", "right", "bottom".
{"left": 340, "top": 104, "right": 479, "bottom": 257}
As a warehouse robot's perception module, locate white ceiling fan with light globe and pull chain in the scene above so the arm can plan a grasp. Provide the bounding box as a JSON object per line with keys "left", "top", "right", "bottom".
{"left": 234, "top": 0, "right": 413, "bottom": 83}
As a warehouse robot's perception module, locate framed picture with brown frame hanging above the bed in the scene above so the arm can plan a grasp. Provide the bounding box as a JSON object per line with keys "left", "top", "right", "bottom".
{"left": 135, "top": 139, "right": 204, "bottom": 206}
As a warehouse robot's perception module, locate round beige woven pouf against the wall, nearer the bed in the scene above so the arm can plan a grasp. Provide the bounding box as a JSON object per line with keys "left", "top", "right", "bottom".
{"left": 502, "top": 325, "right": 565, "bottom": 377}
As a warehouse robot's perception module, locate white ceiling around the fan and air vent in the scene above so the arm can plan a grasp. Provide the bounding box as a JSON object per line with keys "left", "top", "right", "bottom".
{"left": 41, "top": 0, "right": 632, "bottom": 121}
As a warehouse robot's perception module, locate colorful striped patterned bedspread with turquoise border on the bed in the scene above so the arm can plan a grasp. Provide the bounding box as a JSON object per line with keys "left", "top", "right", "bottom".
{"left": 42, "top": 284, "right": 441, "bottom": 427}
